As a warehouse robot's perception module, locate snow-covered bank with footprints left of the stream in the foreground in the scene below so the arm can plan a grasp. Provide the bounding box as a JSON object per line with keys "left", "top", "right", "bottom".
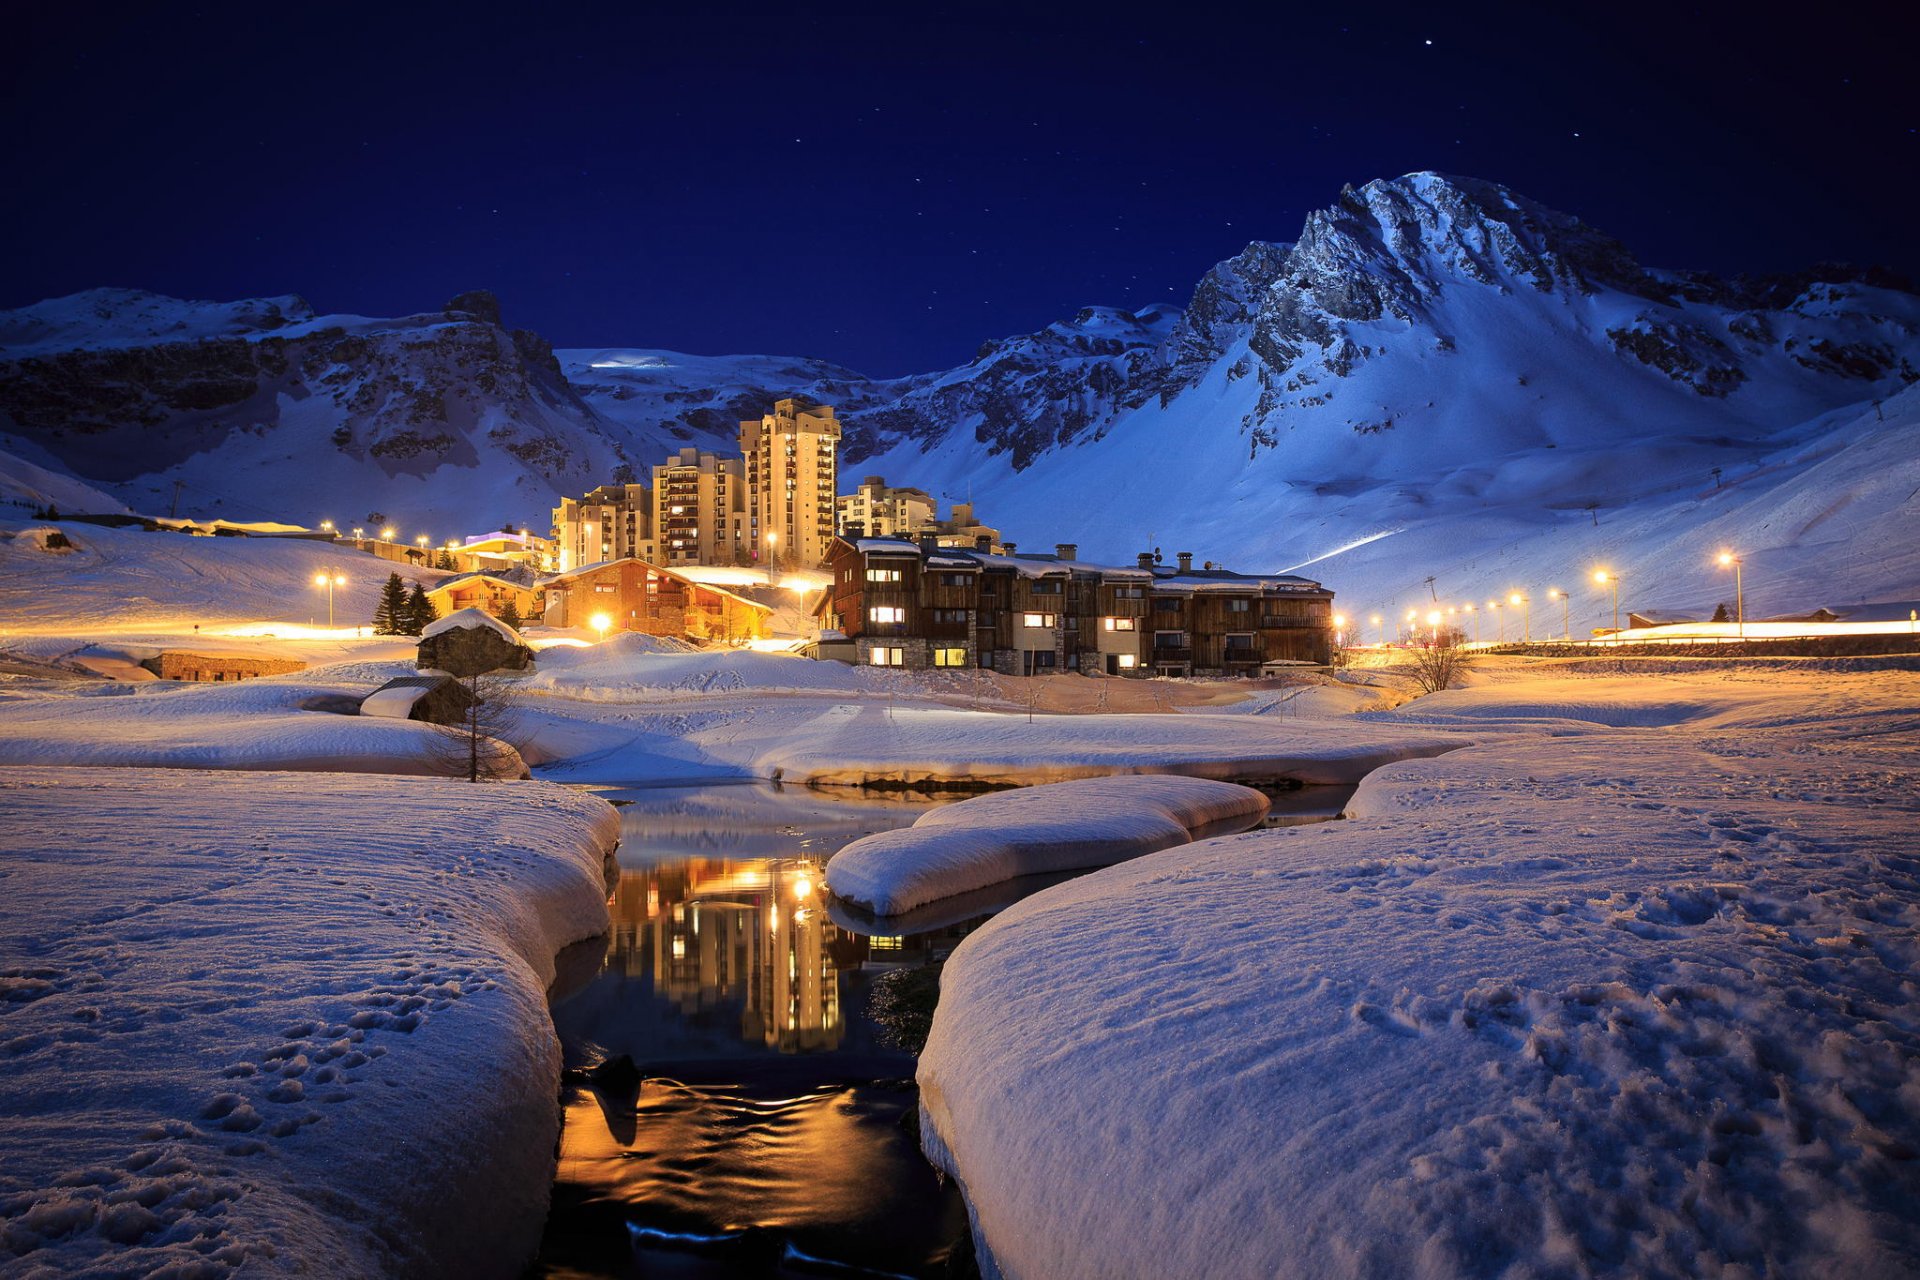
{"left": 0, "top": 768, "right": 618, "bottom": 1276}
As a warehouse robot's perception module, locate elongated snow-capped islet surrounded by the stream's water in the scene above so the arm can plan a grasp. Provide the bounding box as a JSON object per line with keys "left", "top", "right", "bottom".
{"left": 828, "top": 777, "right": 1267, "bottom": 915}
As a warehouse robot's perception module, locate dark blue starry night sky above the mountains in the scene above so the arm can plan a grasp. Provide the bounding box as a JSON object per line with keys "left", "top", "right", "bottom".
{"left": 0, "top": 4, "right": 1920, "bottom": 374}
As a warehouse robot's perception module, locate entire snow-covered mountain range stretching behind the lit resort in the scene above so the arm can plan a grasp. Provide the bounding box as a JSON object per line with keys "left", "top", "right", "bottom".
{"left": 0, "top": 173, "right": 1920, "bottom": 631}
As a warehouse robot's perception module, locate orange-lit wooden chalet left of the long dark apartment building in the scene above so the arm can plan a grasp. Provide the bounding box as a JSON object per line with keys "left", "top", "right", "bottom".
{"left": 540, "top": 557, "right": 774, "bottom": 643}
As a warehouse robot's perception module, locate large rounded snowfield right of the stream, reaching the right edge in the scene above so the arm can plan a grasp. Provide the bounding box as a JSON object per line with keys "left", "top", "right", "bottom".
{"left": 920, "top": 670, "right": 1920, "bottom": 1276}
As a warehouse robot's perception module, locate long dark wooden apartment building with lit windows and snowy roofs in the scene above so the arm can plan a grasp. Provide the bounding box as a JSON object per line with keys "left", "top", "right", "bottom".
{"left": 820, "top": 537, "right": 1334, "bottom": 676}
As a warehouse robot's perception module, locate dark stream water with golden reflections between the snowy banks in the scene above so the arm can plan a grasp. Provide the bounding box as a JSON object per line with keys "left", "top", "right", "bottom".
{"left": 528, "top": 783, "right": 1350, "bottom": 1280}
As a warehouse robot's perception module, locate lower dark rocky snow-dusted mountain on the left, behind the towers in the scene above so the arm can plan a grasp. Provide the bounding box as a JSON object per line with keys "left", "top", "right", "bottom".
{"left": 0, "top": 290, "right": 622, "bottom": 535}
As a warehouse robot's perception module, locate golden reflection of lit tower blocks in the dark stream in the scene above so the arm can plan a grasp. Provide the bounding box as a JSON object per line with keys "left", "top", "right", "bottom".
{"left": 607, "top": 858, "right": 845, "bottom": 1054}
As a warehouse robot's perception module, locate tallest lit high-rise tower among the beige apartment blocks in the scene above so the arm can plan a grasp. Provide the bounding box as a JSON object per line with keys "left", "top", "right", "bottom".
{"left": 739, "top": 399, "right": 841, "bottom": 568}
